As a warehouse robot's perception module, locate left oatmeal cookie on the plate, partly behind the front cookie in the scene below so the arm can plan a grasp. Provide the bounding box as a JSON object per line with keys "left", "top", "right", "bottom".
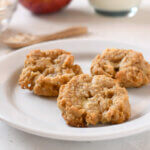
{"left": 19, "top": 49, "right": 82, "bottom": 96}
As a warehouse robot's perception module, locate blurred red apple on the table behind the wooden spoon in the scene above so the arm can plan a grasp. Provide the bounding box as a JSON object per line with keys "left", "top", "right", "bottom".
{"left": 19, "top": 0, "right": 71, "bottom": 14}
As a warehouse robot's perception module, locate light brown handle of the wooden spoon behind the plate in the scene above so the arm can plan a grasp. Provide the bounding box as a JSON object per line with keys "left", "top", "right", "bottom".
{"left": 40, "top": 27, "right": 88, "bottom": 41}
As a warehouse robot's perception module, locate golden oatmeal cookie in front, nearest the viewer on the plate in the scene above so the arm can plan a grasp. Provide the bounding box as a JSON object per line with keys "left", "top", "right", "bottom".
{"left": 57, "top": 74, "right": 130, "bottom": 127}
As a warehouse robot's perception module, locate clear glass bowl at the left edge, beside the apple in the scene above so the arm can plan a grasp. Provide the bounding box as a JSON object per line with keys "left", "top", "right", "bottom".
{"left": 0, "top": 0, "right": 17, "bottom": 32}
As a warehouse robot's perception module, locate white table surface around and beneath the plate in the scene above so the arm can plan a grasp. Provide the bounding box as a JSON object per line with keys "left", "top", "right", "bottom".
{"left": 0, "top": 0, "right": 150, "bottom": 150}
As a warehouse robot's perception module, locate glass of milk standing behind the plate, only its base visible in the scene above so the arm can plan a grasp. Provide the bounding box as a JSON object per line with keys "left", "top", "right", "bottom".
{"left": 89, "top": 0, "right": 141, "bottom": 17}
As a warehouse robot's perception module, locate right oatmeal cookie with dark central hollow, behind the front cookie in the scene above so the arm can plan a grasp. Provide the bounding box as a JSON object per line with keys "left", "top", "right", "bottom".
{"left": 91, "top": 49, "right": 150, "bottom": 87}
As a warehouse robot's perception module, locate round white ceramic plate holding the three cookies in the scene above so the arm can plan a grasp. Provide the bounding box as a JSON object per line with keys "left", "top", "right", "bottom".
{"left": 0, "top": 40, "right": 150, "bottom": 141}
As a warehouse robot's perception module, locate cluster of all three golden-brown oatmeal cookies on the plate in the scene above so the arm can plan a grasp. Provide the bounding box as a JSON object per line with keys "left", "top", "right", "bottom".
{"left": 19, "top": 49, "right": 150, "bottom": 127}
